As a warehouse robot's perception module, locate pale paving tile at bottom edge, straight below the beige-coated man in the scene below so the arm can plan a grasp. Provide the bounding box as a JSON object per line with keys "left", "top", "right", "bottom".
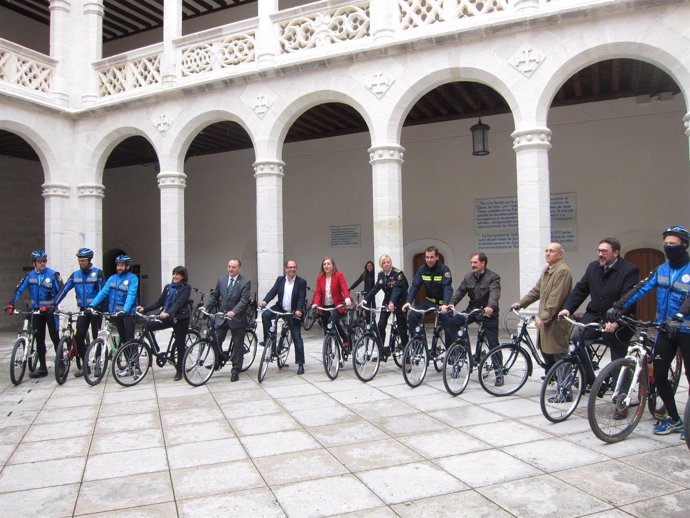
{"left": 477, "top": 475, "right": 611, "bottom": 518}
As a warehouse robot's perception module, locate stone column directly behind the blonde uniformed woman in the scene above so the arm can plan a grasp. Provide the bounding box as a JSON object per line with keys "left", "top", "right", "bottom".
{"left": 369, "top": 143, "right": 405, "bottom": 268}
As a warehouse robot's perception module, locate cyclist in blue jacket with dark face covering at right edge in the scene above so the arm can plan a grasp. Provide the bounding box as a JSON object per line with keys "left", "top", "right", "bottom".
{"left": 607, "top": 225, "right": 690, "bottom": 435}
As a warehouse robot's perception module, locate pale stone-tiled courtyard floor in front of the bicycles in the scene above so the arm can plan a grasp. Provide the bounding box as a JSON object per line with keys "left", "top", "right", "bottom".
{"left": 0, "top": 330, "right": 690, "bottom": 518}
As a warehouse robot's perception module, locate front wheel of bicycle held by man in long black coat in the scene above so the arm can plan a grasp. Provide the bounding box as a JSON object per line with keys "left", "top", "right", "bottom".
{"left": 539, "top": 358, "right": 587, "bottom": 423}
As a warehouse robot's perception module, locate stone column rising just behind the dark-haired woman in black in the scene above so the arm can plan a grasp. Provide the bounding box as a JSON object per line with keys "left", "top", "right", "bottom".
{"left": 158, "top": 171, "right": 187, "bottom": 286}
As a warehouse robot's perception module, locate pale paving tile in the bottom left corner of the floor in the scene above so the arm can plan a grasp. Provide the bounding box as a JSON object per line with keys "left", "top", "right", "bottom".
{"left": 0, "top": 484, "right": 79, "bottom": 518}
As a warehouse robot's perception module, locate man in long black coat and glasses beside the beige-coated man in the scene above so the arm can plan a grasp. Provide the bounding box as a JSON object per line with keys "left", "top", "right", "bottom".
{"left": 559, "top": 237, "right": 640, "bottom": 374}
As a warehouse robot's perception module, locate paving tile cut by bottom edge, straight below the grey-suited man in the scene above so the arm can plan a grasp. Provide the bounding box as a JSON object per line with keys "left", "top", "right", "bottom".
{"left": 178, "top": 488, "right": 286, "bottom": 518}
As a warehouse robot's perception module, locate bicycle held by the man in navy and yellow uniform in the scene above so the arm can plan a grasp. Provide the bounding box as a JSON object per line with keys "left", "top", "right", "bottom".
{"left": 402, "top": 306, "right": 446, "bottom": 388}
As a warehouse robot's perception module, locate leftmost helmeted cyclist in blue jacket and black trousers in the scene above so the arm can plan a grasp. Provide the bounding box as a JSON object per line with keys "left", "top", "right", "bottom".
{"left": 5, "top": 250, "right": 60, "bottom": 378}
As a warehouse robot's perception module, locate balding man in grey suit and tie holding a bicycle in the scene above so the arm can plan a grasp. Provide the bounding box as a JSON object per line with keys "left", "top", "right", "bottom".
{"left": 206, "top": 258, "right": 252, "bottom": 381}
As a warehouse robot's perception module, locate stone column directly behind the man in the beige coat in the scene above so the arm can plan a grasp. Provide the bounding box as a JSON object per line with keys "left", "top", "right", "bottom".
{"left": 511, "top": 127, "right": 551, "bottom": 296}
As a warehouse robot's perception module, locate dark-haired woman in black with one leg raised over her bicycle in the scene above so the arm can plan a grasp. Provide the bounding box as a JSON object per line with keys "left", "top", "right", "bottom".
{"left": 137, "top": 266, "right": 192, "bottom": 381}
